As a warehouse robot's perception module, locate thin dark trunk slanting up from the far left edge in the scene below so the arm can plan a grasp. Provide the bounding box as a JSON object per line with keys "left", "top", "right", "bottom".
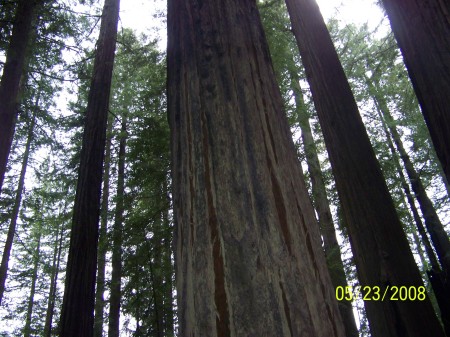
{"left": 0, "top": 109, "right": 35, "bottom": 304}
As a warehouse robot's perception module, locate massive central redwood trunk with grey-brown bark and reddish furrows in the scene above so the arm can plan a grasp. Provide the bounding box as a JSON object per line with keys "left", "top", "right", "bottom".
{"left": 168, "top": 0, "right": 345, "bottom": 337}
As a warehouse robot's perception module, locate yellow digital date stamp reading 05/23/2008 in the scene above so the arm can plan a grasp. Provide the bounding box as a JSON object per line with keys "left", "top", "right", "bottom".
{"left": 336, "top": 285, "right": 427, "bottom": 301}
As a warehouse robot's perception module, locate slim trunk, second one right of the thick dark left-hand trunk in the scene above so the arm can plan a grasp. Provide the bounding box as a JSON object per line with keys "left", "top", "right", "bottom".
{"left": 108, "top": 116, "right": 127, "bottom": 337}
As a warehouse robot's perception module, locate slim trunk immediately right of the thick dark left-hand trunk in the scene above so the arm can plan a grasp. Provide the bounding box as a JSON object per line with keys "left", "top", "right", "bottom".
{"left": 94, "top": 115, "right": 114, "bottom": 337}
